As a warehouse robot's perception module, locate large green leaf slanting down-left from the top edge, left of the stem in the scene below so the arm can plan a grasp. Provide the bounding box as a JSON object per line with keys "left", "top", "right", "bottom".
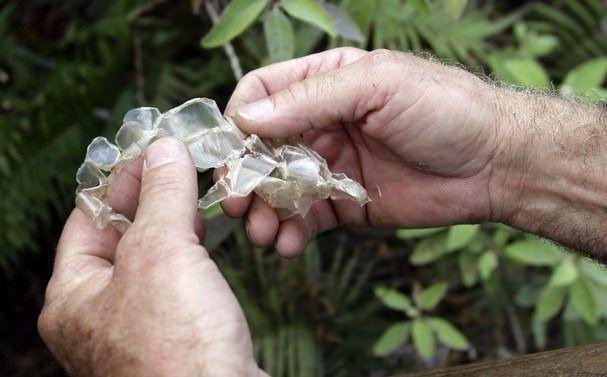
{"left": 202, "top": 0, "right": 268, "bottom": 48}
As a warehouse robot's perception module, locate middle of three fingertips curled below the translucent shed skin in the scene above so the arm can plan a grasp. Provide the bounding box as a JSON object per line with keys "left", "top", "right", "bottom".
{"left": 246, "top": 195, "right": 278, "bottom": 246}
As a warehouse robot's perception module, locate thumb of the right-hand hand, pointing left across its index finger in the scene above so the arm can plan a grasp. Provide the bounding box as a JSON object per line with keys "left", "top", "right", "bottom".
{"left": 234, "top": 59, "right": 377, "bottom": 138}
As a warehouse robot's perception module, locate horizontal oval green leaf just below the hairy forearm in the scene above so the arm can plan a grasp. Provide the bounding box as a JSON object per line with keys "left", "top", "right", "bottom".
{"left": 504, "top": 239, "right": 565, "bottom": 266}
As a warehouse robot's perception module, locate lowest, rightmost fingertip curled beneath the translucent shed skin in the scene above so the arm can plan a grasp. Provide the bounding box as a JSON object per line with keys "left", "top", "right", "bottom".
{"left": 275, "top": 200, "right": 338, "bottom": 258}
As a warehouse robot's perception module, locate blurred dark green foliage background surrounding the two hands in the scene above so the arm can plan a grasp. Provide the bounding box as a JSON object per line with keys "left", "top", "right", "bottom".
{"left": 0, "top": 0, "right": 607, "bottom": 376}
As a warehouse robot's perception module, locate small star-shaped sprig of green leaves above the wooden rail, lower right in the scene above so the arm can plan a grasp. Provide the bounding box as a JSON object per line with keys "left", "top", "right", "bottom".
{"left": 373, "top": 282, "right": 469, "bottom": 359}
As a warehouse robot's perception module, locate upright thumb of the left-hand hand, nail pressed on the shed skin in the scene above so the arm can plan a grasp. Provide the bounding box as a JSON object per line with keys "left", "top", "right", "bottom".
{"left": 135, "top": 137, "right": 198, "bottom": 231}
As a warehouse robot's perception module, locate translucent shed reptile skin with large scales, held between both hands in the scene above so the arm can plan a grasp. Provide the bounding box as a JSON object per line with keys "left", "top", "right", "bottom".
{"left": 76, "top": 98, "right": 369, "bottom": 232}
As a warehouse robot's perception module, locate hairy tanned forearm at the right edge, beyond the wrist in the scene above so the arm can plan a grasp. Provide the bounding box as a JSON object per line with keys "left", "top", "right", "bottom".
{"left": 490, "top": 90, "right": 607, "bottom": 261}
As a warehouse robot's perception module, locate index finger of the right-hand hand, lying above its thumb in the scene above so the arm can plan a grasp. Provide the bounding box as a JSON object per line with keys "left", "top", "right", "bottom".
{"left": 226, "top": 47, "right": 367, "bottom": 116}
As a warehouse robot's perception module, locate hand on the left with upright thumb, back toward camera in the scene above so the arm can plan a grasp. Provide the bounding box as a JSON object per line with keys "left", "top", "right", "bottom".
{"left": 38, "top": 138, "right": 263, "bottom": 376}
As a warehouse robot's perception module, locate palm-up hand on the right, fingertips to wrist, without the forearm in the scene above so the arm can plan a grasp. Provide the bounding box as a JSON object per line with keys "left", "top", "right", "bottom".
{"left": 218, "top": 48, "right": 504, "bottom": 257}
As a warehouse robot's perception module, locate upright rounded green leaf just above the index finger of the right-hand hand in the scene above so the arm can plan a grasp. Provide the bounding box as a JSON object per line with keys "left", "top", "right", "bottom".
{"left": 263, "top": 7, "right": 295, "bottom": 62}
